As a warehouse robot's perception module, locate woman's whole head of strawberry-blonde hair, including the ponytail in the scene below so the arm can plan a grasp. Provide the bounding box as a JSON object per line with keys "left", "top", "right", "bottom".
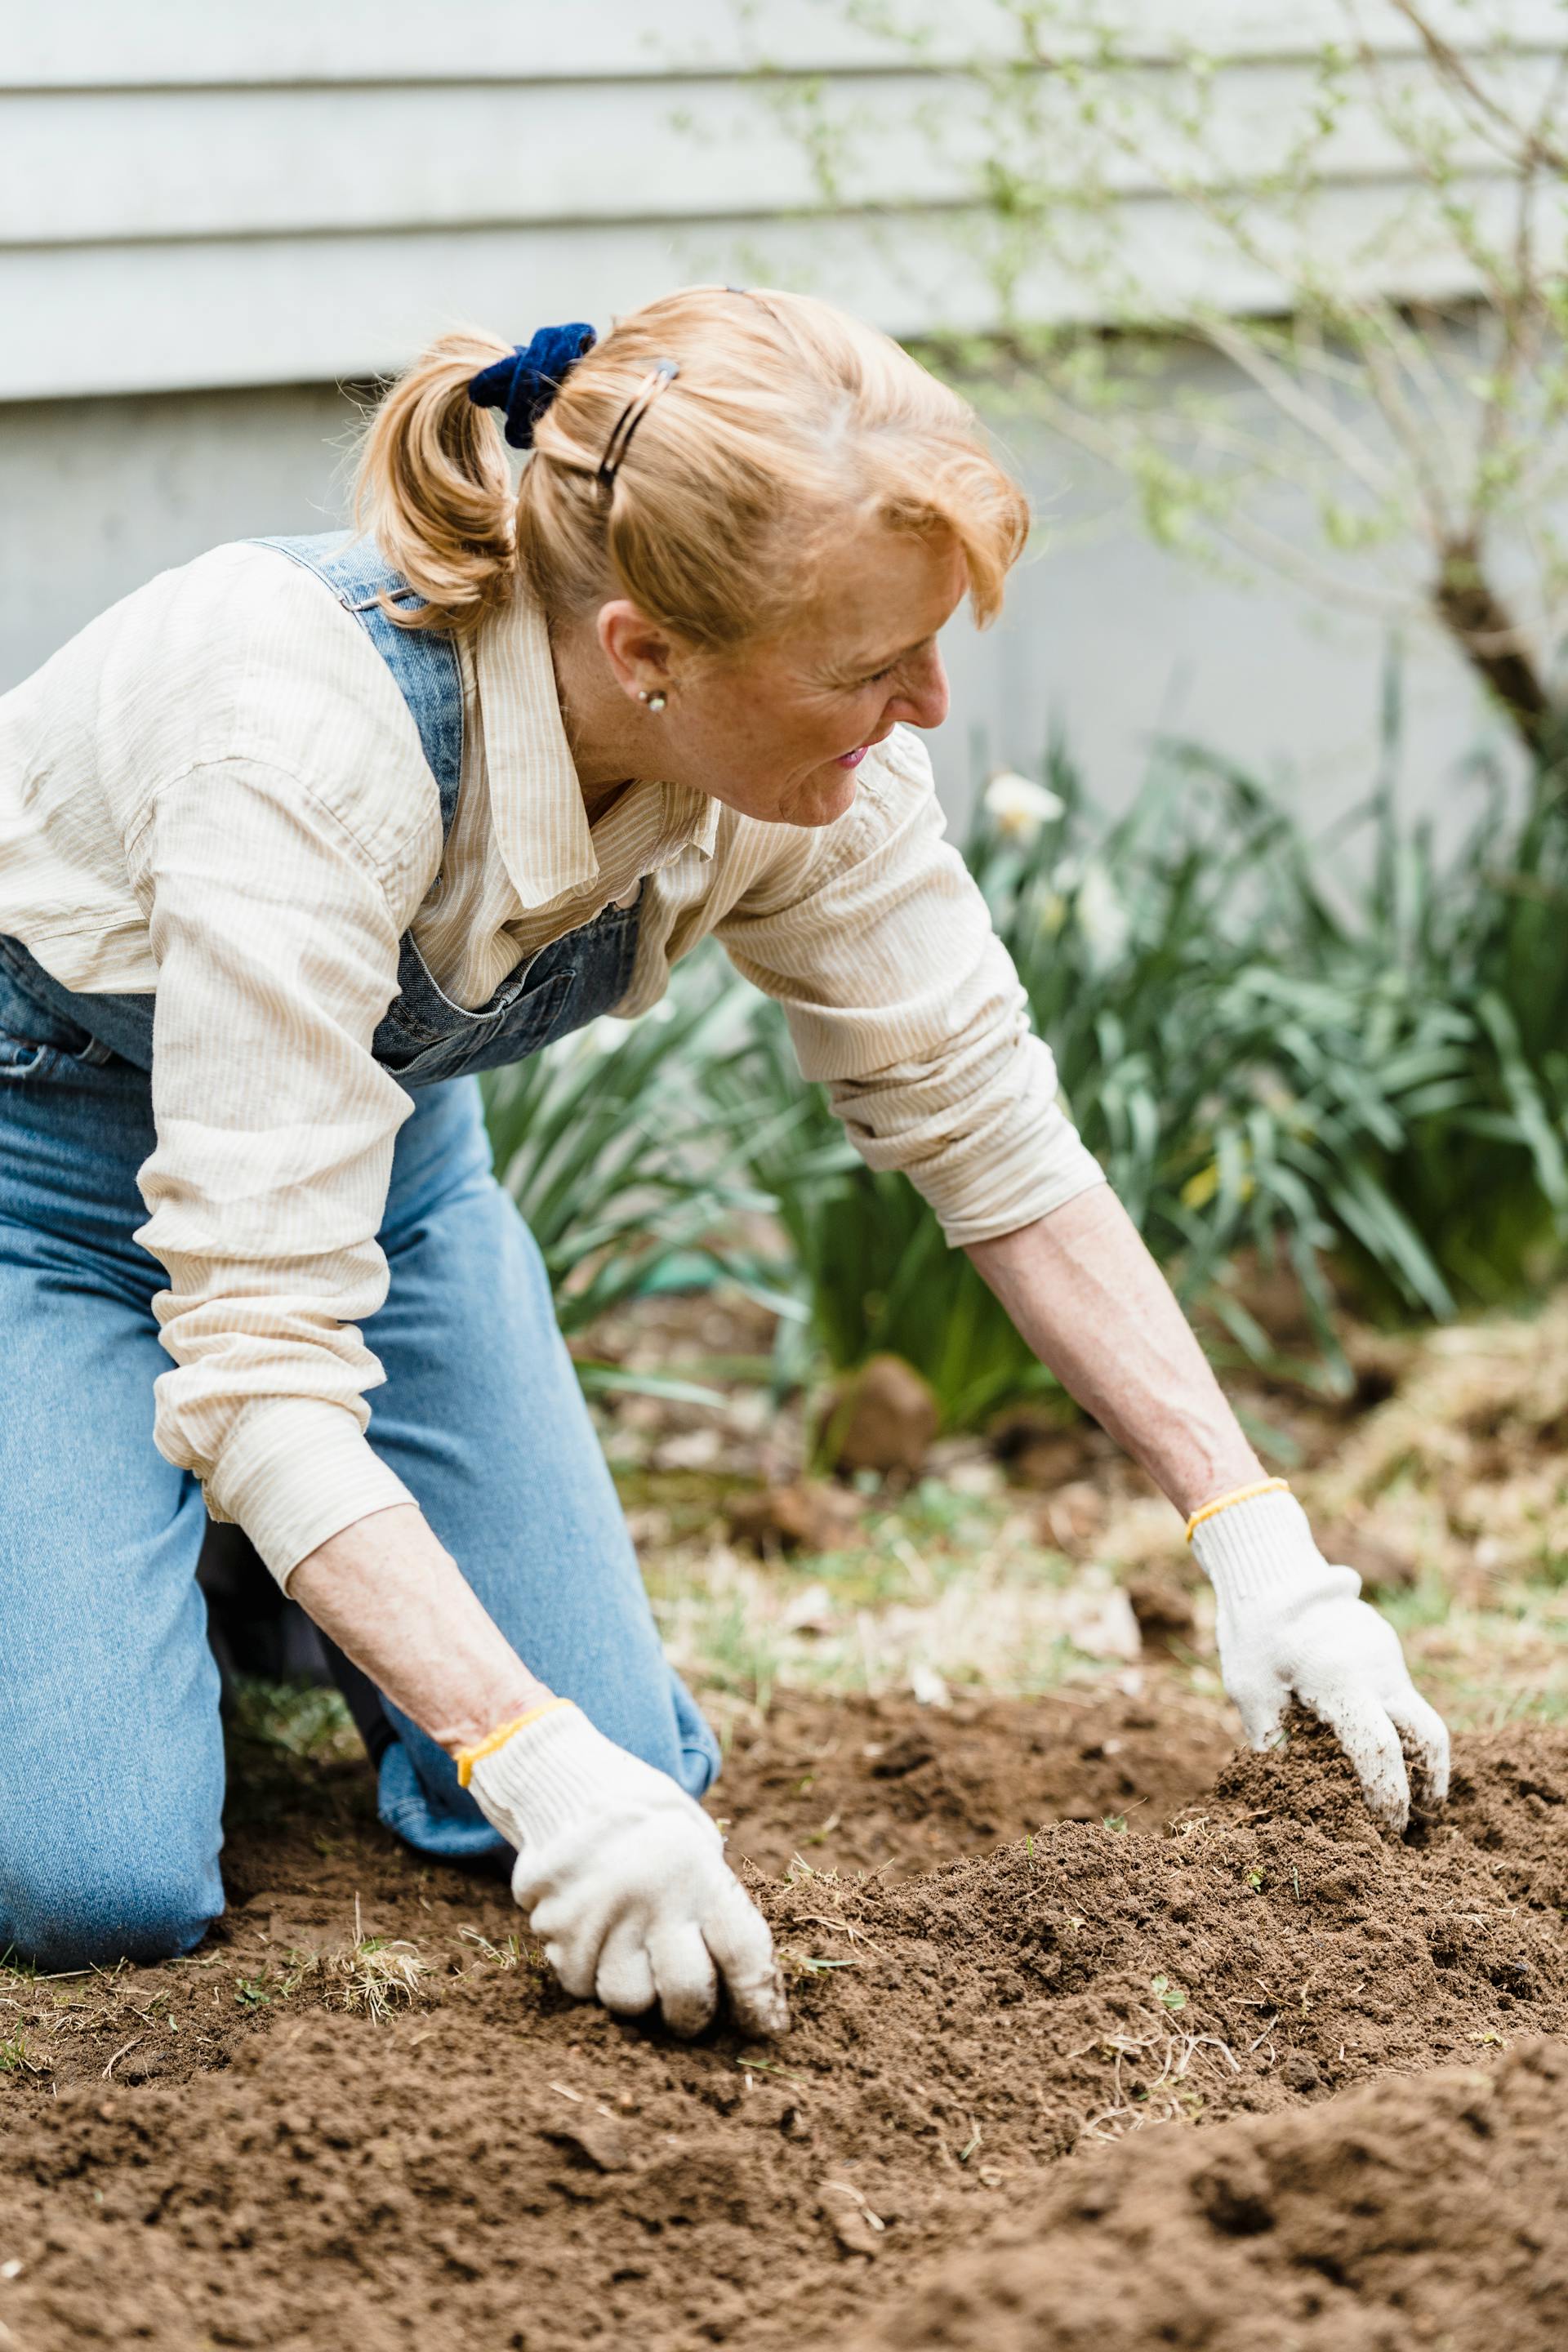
{"left": 355, "top": 287, "right": 1030, "bottom": 654}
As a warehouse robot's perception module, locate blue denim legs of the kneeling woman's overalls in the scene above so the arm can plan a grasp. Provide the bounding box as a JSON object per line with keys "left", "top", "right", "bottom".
{"left": 0, "top": 1006, "right": 719, "bottom": 1969}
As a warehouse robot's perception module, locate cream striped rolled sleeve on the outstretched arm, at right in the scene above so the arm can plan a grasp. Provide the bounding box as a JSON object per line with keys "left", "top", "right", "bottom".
{"left": 717, "top": 729, "right": 1105, "bottom": 1245}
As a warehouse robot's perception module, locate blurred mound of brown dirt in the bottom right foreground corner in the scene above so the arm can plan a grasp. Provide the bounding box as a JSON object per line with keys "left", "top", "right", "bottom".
{"left": 837, "top": 2039, "right": 1568, "bottom": 2352}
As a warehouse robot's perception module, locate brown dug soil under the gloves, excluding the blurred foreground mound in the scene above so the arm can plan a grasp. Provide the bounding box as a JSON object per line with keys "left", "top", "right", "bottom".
{"left": 0, "top": 1731, "right": 1568, "bottom": 2352}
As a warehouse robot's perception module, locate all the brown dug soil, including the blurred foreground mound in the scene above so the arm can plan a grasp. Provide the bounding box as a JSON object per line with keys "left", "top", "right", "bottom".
{"left": 0, "top": 1700, "right": 1568, "bottom": 2352}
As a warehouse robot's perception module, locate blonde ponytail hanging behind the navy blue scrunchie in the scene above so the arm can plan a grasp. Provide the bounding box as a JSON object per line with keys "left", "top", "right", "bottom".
{"left": 355, "top": 329, "right": 517, "bottom": 635}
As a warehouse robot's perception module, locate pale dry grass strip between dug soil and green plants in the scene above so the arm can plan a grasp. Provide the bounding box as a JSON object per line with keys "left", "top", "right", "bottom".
{"left": 628, "top": 1291, "right": 1568, "bottom": 1729}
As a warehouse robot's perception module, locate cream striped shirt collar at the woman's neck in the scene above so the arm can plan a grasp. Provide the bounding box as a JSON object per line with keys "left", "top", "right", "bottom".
{"left": 474, "top": 588, "right": 719, "bottom": 908}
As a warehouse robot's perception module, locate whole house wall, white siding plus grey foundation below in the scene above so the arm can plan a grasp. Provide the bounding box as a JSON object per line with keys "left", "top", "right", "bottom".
{"left": 0, "top": 0, "right": 1532, "bottom": 816}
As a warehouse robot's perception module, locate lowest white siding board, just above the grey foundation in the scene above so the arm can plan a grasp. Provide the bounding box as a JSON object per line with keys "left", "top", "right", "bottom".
{"left": 0, "top": 181, "right": 1542, "bottom": 400}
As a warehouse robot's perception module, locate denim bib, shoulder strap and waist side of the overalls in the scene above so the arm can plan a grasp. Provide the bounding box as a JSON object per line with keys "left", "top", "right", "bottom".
{"left": 0, "top": 532, "right": 637, "bottom": 1087}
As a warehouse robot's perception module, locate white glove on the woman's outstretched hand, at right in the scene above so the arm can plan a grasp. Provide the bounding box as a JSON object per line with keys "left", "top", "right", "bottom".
{"left": 1190, "top": 1486, "right": 1448, "bottom": 1830}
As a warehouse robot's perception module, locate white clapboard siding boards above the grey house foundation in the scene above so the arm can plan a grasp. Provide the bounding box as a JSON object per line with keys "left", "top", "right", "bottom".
{"left": 0, "top": 0, "right": 1568, "bottom": 400}
